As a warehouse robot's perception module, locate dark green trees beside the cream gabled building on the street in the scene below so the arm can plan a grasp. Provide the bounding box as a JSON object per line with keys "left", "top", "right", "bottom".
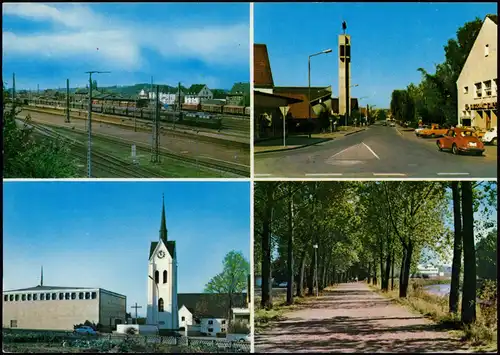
{"left": 391, "top": 15, "right": 497, "bottom": 127}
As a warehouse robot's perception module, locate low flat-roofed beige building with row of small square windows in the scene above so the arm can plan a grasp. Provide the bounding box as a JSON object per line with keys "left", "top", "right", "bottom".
{"left": 2, "top": 282, "right": 127, "bottom": 330}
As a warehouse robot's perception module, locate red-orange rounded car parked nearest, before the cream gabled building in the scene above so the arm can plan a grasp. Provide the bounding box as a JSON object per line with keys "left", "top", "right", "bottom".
{"left": 436, "top": 128, "right": 484, "bottom": 155}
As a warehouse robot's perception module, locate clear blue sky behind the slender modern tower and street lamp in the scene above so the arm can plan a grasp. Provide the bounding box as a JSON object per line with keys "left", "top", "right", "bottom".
{"left": 254, "top": 2, "right": 497, "bottom": 108}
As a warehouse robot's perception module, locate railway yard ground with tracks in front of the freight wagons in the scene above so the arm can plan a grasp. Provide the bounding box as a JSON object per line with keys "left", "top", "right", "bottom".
{"left": 17, "top": 106, "right": 250, "bottom": 178}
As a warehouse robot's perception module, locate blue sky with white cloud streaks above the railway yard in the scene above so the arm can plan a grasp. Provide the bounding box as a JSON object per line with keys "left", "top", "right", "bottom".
{"left": 2, "top": 3, "right": 250, "bottom": 89}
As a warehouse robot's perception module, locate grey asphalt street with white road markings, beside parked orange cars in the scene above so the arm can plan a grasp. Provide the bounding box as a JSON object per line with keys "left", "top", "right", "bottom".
{"left": 255, "top": 124, "right": 497, "bottom": 178}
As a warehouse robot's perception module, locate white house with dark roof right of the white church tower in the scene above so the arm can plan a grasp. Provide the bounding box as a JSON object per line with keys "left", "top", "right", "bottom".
{"left": 177, "top": 293, "right": 248, "bottom": 337}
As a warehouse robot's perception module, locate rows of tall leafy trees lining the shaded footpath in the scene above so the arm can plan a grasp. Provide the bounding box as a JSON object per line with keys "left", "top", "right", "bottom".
{"left": 254, "top": 181, "right": 496, "bottom": 323}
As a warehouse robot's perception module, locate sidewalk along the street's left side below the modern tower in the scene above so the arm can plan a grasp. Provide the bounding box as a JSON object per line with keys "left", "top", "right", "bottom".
{"left": 254, "top": 127, "right": 366, "bottom": 154}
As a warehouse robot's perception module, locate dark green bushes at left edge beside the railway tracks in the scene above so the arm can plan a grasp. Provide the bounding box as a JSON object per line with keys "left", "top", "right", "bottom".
{"left": 3, "top": 85, "right": 78, "bottom": 178}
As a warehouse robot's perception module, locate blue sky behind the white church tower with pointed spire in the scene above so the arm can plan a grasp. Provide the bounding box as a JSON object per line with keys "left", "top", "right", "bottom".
{"left": 3, "top": 182, "right": 250, "bottom": 318}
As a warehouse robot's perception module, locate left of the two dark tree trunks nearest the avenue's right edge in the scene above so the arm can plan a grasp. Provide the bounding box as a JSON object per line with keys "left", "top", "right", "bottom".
{"left": 449, "top": 181, "right": 462, "bottom": 313}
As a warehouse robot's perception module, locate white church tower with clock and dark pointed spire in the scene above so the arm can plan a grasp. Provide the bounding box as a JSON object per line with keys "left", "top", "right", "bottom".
{"left": 147, "top": 195, "right": 179, "bottom": 331}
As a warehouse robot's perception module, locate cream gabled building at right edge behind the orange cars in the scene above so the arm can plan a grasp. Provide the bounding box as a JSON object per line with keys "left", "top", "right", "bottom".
{"left": 457, "top": 15, "right": 498, "bottom": 129}
